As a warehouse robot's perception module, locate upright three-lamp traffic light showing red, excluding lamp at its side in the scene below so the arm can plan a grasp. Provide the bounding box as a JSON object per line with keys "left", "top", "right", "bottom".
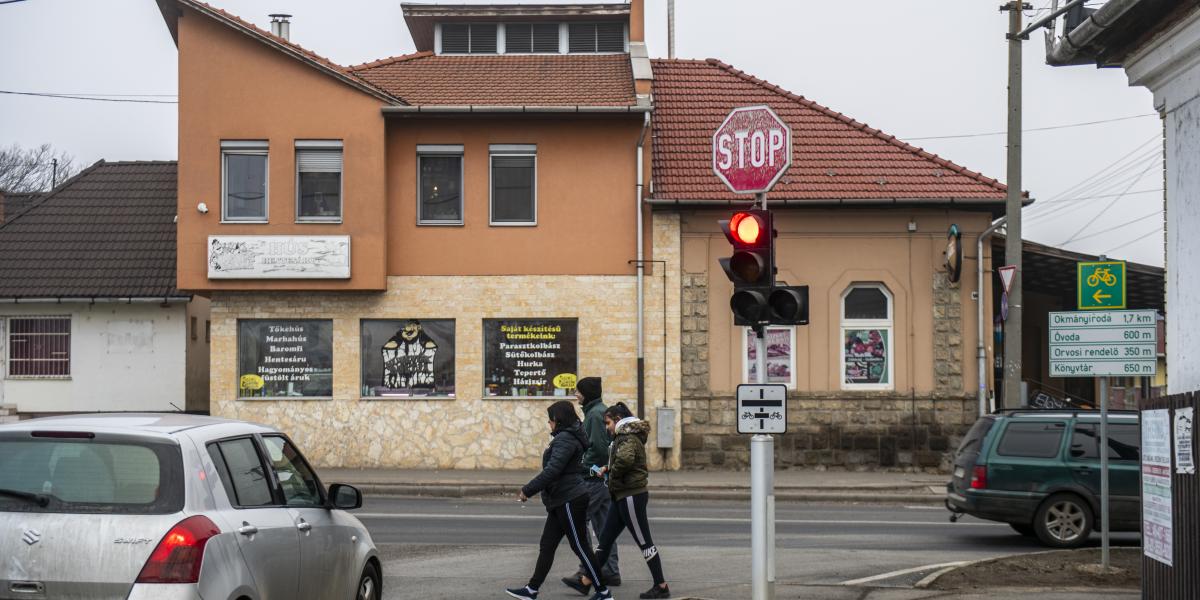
{"left": 720, "top": 209, "right": 775, "bottom": 325}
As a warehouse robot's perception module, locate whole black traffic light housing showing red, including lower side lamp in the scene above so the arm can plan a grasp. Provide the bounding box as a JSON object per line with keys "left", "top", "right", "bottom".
{"left": 720, "top": 209, "right": 809, "bottom": 328}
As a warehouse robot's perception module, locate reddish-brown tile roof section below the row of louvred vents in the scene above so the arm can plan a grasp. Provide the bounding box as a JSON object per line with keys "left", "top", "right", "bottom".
{"left": 349, "top": 52, "right": 636, "bottom": 106}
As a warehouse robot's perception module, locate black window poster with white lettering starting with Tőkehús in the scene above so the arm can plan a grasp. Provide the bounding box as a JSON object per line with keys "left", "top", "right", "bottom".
{"left": 238, "top": 320, "right": 334, "bottom": 398}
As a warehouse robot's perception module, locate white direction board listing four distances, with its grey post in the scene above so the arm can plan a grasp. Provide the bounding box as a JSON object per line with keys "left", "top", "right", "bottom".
{"left": 1050, "top": 309, "right": 1158, "bottom": 570}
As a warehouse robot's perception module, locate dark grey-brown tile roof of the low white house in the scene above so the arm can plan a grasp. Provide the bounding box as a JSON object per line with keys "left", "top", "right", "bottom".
{"left": 0, "top": 161, "right": 184, "bottom": 298}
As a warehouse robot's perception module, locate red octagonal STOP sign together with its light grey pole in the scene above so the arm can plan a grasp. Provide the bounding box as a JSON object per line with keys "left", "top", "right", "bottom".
{"left": 713, "top": 106, "right": 792, "bottom": 600}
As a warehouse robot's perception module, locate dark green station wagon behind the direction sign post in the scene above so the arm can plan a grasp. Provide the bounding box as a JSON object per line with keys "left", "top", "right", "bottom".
{"left": 946, "top": 410, "right": 1141, "bottom": 548}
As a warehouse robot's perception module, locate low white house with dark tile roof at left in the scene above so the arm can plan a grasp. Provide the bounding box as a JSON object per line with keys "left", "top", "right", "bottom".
{"left": 0, "top": 161, "right": 209, "bottom": 416}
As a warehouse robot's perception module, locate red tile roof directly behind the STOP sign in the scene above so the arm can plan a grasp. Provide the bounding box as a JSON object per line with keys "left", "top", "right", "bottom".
{"left": 650, "top": 59, "right": 1007, "bottom": 204}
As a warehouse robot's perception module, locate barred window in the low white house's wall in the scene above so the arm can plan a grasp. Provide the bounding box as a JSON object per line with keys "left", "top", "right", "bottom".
{"left": 8, "top": 317, "right": 71, "bottom": 377}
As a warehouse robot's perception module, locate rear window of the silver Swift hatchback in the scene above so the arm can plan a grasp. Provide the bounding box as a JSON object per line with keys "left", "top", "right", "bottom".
{"left": 0, "top": 438, "right": 184, "bottom": 515}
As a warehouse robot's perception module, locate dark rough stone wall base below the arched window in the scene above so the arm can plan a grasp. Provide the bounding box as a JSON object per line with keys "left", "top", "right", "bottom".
{"left": 683, "top": 392, "right": 976, "bottom": 470}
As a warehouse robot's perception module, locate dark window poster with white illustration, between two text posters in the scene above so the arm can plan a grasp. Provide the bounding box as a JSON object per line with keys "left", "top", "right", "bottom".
{"left": 360, "top": 319, "right": 455, "bottom": 397}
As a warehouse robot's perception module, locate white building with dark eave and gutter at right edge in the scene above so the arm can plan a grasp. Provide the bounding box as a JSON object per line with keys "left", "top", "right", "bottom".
{"left": 1046, "top": 0, "right": 1200, "bottom": 394}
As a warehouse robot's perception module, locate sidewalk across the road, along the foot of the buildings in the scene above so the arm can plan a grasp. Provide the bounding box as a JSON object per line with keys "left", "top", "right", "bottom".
{"left": 318, "top": 468, "right": 949, "bottom": 505}
